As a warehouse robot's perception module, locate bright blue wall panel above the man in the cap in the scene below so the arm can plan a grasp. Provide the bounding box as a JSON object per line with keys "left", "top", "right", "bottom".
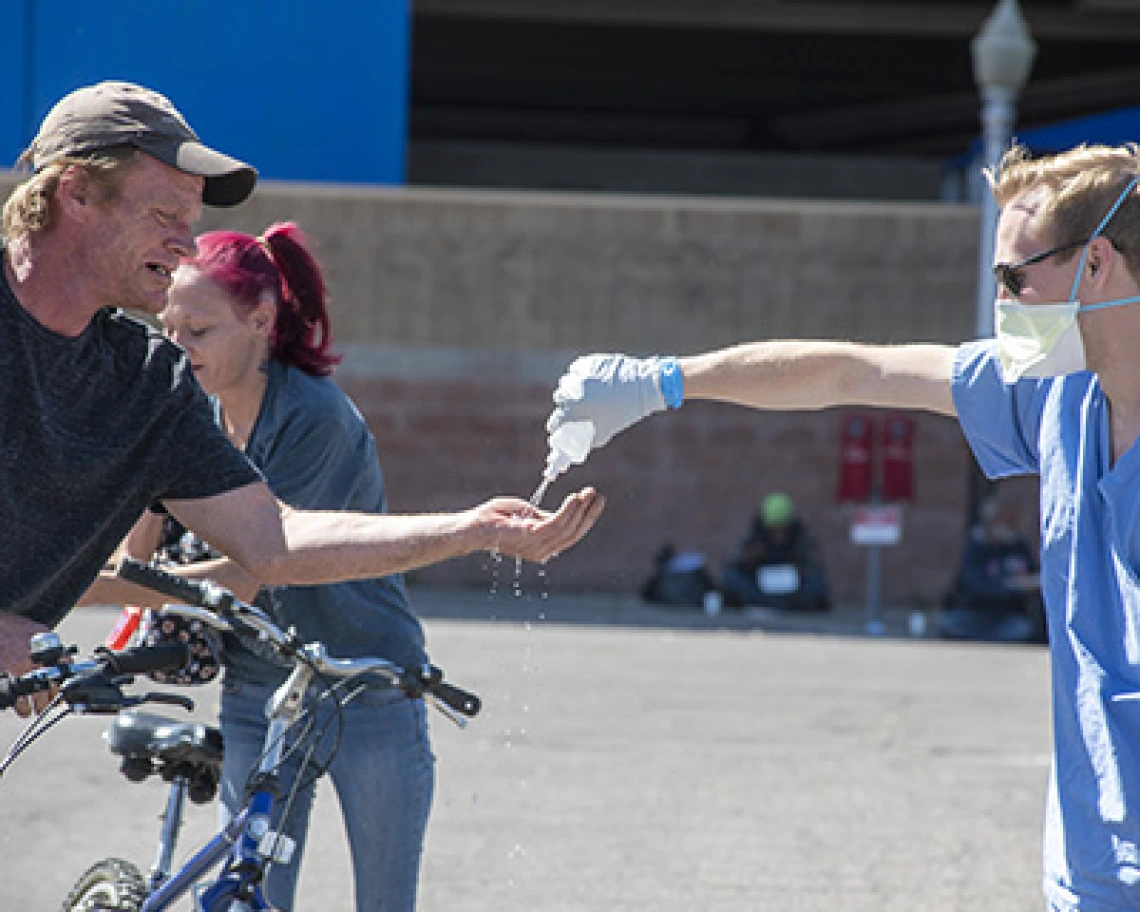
{"left": 0, "top": 0, "right": 410, "bottom": 184}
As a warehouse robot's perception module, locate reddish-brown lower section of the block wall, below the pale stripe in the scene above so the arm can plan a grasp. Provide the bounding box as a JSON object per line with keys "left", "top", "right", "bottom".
{"left": 345, "top": 380, "right": 984, "bottom": 603}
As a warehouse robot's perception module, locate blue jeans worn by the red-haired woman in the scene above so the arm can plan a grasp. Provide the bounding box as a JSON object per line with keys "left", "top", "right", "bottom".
{"left": 219, "top": 675, "right": 435, "bottom": 912}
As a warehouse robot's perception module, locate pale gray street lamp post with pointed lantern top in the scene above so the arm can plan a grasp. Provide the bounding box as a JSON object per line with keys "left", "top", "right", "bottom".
{"left": 970, "top": 0, "right": 1037, "bottom": 339}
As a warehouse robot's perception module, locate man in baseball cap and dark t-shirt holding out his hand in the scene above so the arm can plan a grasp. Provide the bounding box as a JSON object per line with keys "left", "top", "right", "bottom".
{"left": 0, "top": 82, "right": 603, "bottom": 711}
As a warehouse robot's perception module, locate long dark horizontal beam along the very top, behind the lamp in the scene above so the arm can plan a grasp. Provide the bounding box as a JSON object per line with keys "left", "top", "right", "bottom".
{"left": 412, "top": 0, "right": 1140, "bottom": 41}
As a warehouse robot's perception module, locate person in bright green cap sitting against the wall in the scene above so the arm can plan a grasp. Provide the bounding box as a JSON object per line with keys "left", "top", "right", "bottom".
{"left": 722, "top": 491, "right": 831, "bottom": 611}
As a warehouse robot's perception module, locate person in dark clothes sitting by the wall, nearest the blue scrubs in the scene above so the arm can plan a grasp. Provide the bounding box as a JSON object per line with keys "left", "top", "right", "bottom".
{"left": 938, "top": 496, "right": 1044, "bottom": 643}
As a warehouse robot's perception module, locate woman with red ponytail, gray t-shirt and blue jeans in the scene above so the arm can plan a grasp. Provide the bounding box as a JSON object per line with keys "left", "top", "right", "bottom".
{"left": 156, "top": 223, "right": 434, "bottom": 912}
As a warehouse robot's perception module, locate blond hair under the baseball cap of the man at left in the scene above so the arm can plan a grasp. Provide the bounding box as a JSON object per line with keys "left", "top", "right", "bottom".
{"left": 0, "top": 146, "right": 139, "bottom": 239}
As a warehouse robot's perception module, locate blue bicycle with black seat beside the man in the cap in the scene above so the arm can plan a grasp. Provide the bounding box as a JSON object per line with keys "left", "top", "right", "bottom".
{"left": 0, "top": 559, "right": 480, "bottom": 912}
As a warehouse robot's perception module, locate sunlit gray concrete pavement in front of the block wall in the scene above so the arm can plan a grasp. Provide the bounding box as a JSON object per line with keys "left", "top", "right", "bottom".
{"left": 0, "top": 592, "right": 1049, "bottom": 912}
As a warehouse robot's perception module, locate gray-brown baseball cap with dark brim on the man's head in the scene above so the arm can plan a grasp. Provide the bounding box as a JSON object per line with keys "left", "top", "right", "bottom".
{"left": 21, "top": 81, "right": 258, "bottom": 206}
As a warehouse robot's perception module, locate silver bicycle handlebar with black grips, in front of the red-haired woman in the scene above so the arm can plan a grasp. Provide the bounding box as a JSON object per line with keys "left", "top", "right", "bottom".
{"left": 116, "top": 557, "right": 482, "bottom": 717}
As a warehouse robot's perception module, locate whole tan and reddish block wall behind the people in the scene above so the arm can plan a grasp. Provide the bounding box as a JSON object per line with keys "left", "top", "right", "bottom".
{"left": 0, "top": 176, "right": 1035, "bottom": 603}
